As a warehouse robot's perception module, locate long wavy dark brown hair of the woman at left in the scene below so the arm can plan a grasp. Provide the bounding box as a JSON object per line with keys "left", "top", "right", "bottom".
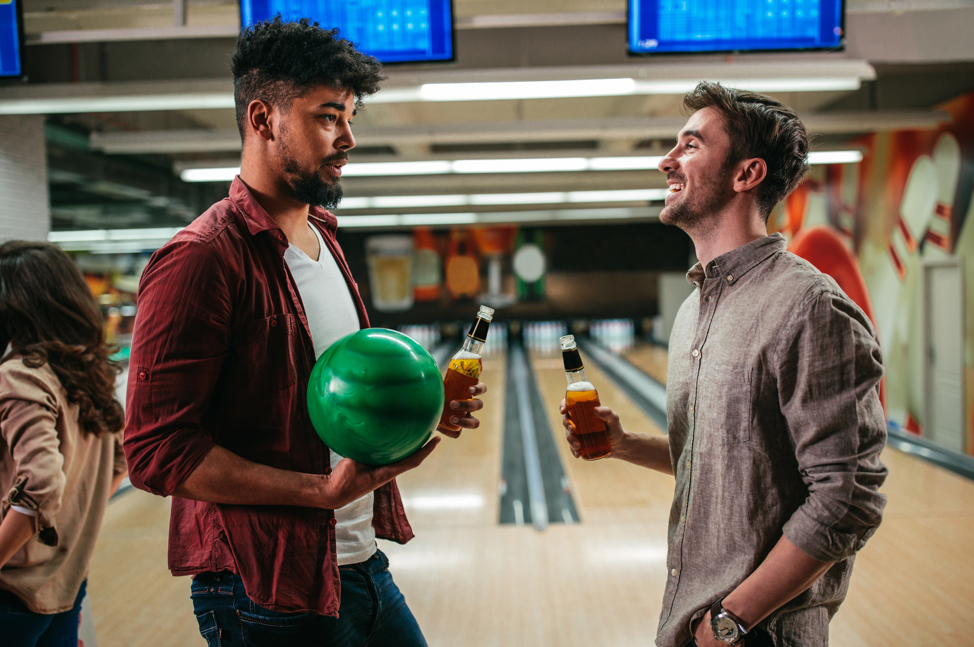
{"left": 0, "top": 240, "right": 125, "bottom": 435}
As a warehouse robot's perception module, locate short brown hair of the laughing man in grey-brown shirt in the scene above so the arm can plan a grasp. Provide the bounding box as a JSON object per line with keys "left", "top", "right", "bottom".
{"left": 683, "top": 82, "right": 809, "bottom": 221}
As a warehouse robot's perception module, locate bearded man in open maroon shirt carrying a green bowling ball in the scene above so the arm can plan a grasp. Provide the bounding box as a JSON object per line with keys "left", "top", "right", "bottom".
{"left": 125, "top": 18, "right": 486, "bottom": 647}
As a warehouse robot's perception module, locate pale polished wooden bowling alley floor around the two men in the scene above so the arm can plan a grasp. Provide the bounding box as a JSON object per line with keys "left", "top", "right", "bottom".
{"left": 88, "top": 346, "right": 974, "bottom": 647}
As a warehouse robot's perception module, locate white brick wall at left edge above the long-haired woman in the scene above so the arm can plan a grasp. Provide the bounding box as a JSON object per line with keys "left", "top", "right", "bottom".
{"left": 0, "top": 115, "right": 51, "bottom": 241}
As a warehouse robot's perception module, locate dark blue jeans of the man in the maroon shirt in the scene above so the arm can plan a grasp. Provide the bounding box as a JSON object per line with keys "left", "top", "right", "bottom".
{"left": 192, "top": 550, "right": 427, "bottom": 647}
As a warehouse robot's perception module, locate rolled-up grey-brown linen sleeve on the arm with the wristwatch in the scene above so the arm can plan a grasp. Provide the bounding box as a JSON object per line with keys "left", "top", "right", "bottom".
{"left": 777, "top": 289, "right": 887, "bottom": 562}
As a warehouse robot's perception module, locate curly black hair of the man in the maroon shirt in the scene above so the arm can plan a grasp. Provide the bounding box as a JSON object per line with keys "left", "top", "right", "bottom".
{"left": 230, "top": 15, "right": 385, "bottom": 139}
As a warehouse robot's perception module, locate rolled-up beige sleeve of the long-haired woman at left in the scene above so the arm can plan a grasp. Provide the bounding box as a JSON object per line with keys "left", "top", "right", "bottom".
{"left": 0, "top": 362, "right": 66, "bottom": 546}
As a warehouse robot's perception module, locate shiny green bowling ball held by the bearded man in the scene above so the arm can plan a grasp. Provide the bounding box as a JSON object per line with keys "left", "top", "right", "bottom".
{"left": 308, "top": 328, "right": 443, "bottom": 465}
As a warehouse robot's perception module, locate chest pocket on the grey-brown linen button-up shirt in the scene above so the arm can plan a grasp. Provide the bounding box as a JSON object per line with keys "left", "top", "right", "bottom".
{"left": 696, "top": 364, "right": 754, "bottom": 446}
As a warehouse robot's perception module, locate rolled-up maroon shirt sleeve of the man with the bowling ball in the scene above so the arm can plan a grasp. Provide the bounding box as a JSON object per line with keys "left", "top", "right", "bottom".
{"left": 124, "top": 238, "right": 232, "bottom": 496}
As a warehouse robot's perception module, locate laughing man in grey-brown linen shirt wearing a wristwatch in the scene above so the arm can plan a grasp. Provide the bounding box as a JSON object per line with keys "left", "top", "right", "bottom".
{"left": 562, "top": 83, "right": 886, "bottom": 647}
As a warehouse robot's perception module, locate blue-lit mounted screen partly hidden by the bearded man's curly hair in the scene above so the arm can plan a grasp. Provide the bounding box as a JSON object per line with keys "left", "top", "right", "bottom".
{"left": 240, "top": 0, "right": 453, "bottom": 63}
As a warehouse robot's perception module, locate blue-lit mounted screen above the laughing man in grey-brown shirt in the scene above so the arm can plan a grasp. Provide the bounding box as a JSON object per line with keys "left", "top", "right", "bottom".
{"left": 629, "top": 0, "right": 845, "bottom": 54}
